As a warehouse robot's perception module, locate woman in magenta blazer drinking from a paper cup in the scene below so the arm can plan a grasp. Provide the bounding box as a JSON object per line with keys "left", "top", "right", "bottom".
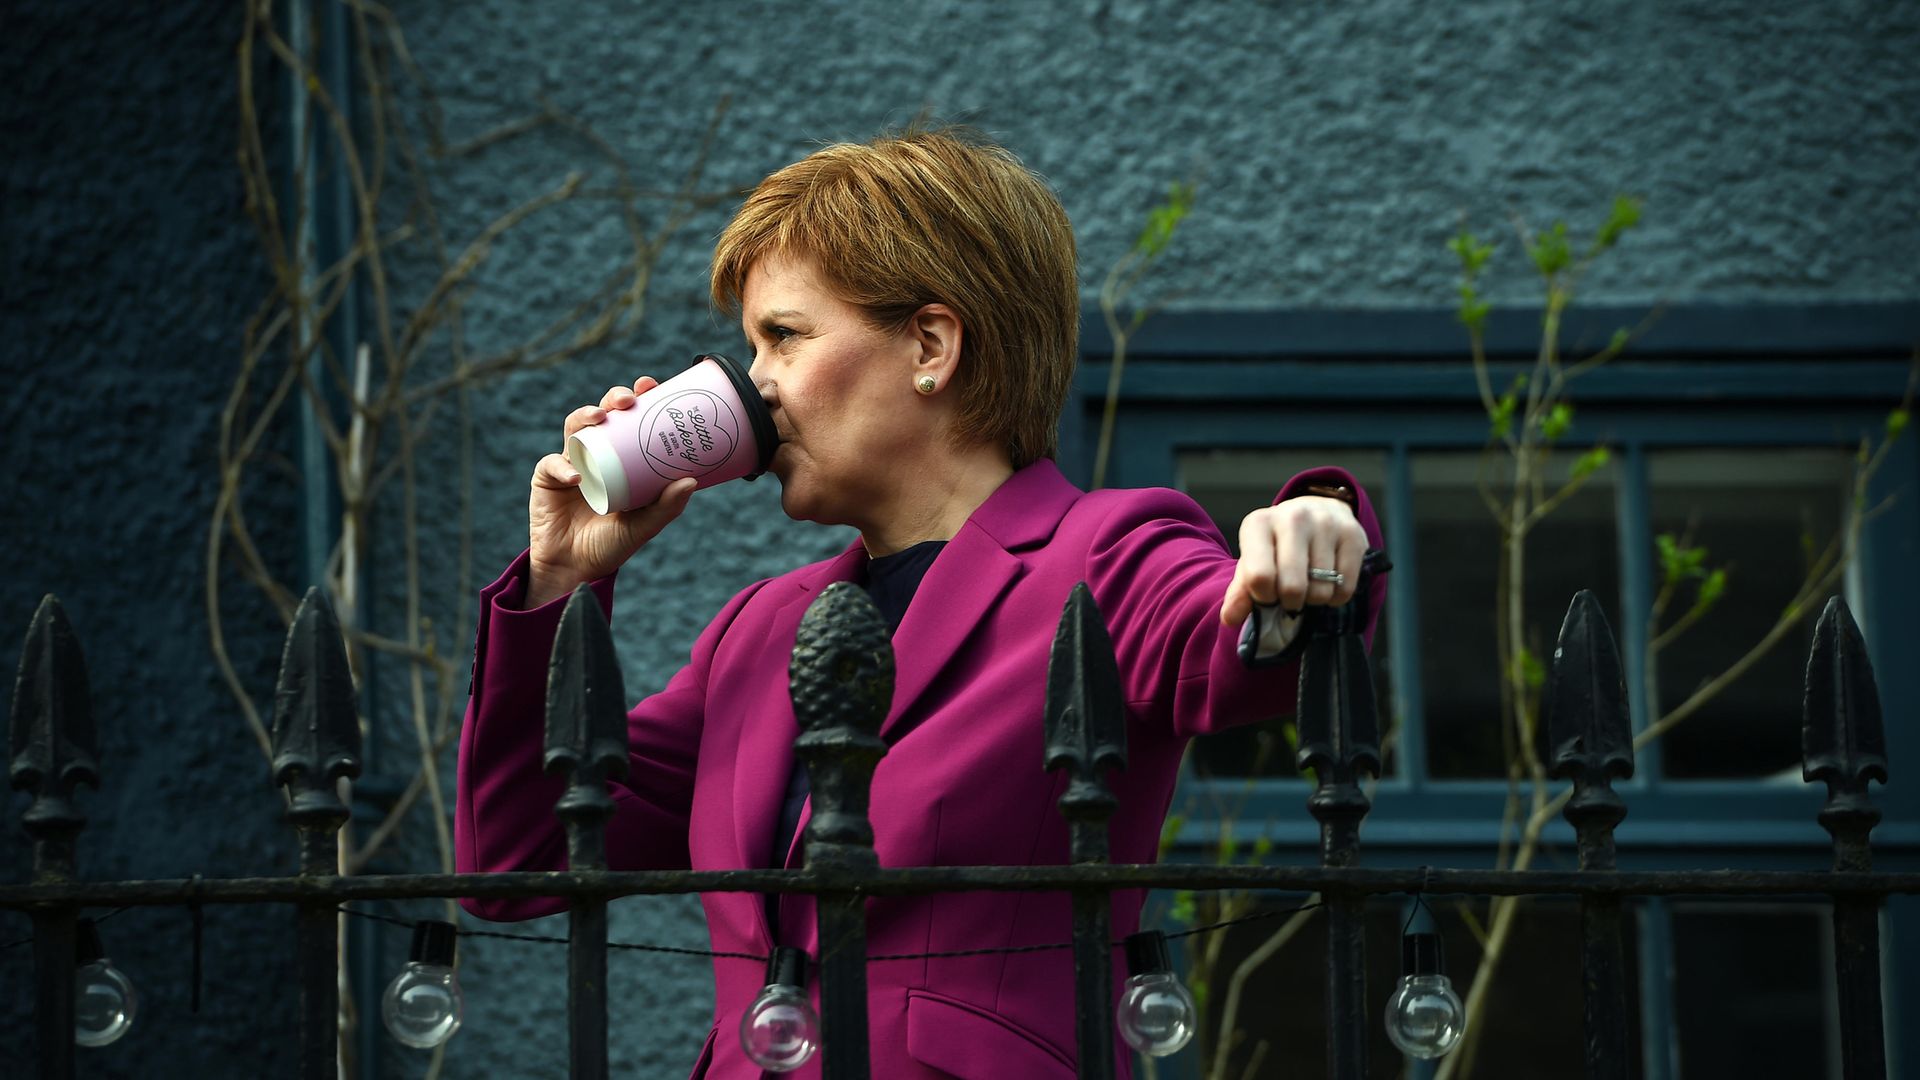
{"left": 457, "top": 131, "right": 1380, "bottom": 1078}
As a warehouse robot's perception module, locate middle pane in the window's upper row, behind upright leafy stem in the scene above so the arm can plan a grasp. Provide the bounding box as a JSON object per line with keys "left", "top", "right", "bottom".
{"left": 1411, "top": 452, "right": 1620, "bottom": 778}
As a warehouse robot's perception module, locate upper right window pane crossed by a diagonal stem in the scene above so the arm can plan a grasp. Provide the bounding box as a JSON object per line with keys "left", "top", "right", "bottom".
{"left": 1647, "top": 450, "right": 1847, "bottom": 786}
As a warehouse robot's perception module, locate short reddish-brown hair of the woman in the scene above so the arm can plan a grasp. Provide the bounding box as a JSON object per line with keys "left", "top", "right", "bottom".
{"left": 710, "top": 127, "right": 1079, "bottom": 469}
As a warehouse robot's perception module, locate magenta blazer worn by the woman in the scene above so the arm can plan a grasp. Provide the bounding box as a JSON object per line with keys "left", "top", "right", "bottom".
{"left": 455, "top": 461, "right": 1384, "bottom": 1080}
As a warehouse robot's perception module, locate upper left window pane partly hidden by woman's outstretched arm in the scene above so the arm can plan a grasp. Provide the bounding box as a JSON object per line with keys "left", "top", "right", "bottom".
{"left": 1177, "top": 448, "right": 1396, "bottom": 776}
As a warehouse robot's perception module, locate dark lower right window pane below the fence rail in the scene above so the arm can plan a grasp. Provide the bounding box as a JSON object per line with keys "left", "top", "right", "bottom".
{"left": 1672, "top": 903, "right": 1839, "bottom": 1080}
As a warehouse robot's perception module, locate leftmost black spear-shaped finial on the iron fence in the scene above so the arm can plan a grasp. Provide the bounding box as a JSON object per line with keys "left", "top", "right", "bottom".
{"left": 8, "top": 594, "right": 100, "bottom": 876}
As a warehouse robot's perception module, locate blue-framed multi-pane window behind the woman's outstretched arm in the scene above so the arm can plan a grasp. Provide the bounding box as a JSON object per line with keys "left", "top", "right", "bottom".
{"left": 1064, "top": 311, "right": 1920, "bottom": 1080}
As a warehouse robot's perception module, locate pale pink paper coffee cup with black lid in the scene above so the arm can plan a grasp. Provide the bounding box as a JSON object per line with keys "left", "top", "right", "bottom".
{"left": 566, "top": 352, "right": 780, "bottom": 513}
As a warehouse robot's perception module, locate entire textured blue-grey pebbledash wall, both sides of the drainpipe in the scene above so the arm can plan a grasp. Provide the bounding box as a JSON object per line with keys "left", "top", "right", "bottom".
{"left": 0, "top": 0, "right": 1920, "bottom": 1076}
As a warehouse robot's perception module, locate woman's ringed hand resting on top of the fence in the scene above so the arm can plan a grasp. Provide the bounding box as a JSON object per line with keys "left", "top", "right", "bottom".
{"left": 1219, "top": 496, "right": 1367, "bottom": 626}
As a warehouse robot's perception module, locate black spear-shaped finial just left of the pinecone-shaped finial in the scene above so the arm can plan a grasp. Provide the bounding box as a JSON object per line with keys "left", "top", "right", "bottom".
{"left": 541, "top": 586, "right": 628, "bottom": 871}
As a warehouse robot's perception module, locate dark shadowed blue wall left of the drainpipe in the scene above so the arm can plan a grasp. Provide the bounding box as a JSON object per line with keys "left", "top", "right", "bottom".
{"left": 0, "top": 0, "right": 300, "bottom": 1076}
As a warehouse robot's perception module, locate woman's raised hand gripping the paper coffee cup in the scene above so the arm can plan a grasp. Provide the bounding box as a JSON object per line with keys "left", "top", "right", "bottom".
{"left": 526, "top": 377, "right": 697, "bottom": 609}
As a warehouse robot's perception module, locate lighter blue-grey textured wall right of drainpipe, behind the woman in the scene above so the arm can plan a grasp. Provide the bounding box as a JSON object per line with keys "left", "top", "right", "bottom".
{"left": 393, "top": 0, "right": 1920, "bottom": 1076}
